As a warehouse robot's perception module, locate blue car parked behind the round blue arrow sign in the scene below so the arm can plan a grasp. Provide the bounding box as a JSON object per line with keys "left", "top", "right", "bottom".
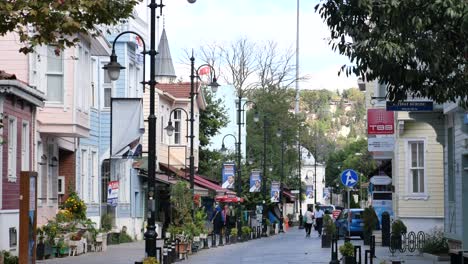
{"left": 335, "top": 208, "right": 364, "bottom": 238}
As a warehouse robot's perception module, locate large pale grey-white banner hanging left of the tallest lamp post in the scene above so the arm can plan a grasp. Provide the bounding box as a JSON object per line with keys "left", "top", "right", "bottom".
{"left": 111, "top": 98, "right": 145, "bottom": 159}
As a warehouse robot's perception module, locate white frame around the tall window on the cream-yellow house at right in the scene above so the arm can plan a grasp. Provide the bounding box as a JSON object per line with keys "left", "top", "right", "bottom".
{"left": 404, "top": 138, "right": 429, "bottom": 200}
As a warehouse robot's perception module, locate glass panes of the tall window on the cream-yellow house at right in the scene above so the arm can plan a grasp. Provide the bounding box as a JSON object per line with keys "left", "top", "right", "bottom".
{"left": 408, "top": 141, "right": 425, "bottom": 193}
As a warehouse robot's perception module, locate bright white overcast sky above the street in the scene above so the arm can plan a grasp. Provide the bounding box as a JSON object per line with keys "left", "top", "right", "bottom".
{"left": 139, "top": 0, "right": 357, "bottom": 90}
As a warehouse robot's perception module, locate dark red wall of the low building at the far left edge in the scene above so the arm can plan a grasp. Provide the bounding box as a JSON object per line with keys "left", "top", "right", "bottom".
{"left": 1, "top": 95, "right": 34, "bottom": 210}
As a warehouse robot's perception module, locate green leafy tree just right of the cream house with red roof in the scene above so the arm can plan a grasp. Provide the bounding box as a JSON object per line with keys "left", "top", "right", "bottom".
{"left": 198, "top": 88, "right": 228, "bottom": 180}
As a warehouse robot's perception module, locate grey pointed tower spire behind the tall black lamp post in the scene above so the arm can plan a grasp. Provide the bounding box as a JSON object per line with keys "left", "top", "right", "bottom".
{"left": 156, "top": 27, "right": 177, "bottom": 83}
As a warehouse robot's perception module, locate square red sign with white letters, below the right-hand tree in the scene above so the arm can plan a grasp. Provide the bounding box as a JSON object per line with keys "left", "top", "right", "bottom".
{"left": 367, "top": 109, "right": 395, "bottom": 135}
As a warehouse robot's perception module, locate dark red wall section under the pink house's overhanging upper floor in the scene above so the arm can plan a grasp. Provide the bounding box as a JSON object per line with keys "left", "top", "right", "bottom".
{"left": 58, "top": 149, "right": 76, "bottom": 202}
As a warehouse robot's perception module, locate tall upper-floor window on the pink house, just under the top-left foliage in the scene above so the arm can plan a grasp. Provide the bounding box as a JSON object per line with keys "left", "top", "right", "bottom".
{"left": 46, "top": 46, "right": 63, "bottom": 103}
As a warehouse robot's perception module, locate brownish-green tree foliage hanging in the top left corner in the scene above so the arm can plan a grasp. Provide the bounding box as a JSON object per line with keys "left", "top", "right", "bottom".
{"left": 0, "top": 0, "right": 141, "bottom": 53}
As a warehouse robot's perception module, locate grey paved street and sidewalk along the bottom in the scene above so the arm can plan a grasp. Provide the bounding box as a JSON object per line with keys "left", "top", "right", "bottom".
{"left": 38, "top": 227, "right": 446, "bottom": 264}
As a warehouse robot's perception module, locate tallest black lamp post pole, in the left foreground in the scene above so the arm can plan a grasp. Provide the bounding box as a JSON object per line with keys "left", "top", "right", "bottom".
{"left": 144, "top": 0, "right": 164, "bottom": 257}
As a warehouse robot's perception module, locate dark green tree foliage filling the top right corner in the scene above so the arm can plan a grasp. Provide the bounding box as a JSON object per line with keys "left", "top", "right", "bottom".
{"left": 316, "top": 0, "right": 468, "bottom": 105}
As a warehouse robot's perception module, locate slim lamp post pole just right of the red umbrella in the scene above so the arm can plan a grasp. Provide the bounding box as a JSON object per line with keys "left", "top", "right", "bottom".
{"left": 237, "top": 96, "right": 242, "bottom": 239}
